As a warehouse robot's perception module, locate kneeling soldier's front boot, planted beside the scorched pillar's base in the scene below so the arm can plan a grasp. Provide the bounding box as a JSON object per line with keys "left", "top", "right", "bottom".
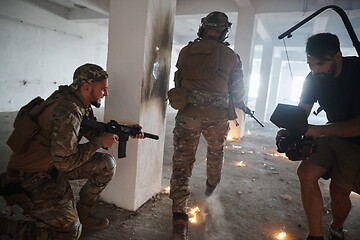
{"left": 76, "top": 203, "right": 109, "bottom": 230}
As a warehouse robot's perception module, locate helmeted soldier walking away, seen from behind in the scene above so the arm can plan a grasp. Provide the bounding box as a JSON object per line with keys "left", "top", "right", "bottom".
{"left": 168, "top": 12, "right": 244, "bottom": 239}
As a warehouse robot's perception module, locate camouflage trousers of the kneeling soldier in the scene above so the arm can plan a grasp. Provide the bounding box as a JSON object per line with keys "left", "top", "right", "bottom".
{"left": 0, "top": 153, "right": 116, "bottom": 240}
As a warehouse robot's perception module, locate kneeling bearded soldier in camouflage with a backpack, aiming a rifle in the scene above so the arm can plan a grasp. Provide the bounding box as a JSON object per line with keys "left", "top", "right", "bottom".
{"left": 0, "top": 64, "right": 143, "bottom": 240}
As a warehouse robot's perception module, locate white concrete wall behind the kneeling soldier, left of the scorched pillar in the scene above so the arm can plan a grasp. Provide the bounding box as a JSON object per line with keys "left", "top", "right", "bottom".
{"left": 0, "top": 0, "right": 108, "bottom": 112}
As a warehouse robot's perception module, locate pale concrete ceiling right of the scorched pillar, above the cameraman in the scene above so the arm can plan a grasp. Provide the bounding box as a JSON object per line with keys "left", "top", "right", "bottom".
{"left": 174, "top": 0, "right": 360, "bottom": 57}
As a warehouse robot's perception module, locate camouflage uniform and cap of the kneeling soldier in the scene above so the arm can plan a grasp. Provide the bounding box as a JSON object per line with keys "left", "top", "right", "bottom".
{"left": 1, "top": 64, "right": 116, "bottom": 240}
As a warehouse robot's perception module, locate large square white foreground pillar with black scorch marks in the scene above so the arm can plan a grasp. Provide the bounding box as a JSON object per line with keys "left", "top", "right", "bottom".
{"left": 101, "top": 0, "right": 176, "bottom": 211}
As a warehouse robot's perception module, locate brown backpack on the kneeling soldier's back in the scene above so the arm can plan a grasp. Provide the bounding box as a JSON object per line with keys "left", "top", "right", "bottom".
{"left": 6, "top": 97, "right": 44, "bottom": 154}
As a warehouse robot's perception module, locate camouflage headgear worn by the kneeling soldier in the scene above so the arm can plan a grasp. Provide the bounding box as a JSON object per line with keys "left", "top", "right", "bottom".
{"left": 70, "top": 63, "right": 108, "bottom": 89}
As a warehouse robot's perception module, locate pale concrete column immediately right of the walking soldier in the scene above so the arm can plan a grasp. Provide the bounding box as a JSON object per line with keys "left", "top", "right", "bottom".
{"left": 229, "top": 7, "right": 256, "bottom": 139}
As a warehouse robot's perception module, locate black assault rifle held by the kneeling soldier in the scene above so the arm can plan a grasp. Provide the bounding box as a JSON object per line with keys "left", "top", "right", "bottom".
{"left": 81, "top": 118, "right": 159, "bottom": 158}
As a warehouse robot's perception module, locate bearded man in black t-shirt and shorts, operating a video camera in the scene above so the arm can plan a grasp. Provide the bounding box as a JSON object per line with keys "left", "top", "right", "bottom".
{"left": 277, "top": 33, "right": 360, "bottom": 240}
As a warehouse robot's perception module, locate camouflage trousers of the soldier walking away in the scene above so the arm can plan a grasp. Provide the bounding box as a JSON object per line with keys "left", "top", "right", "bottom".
{"left": 170, "top": 116, "right": 229, "bottom": 212}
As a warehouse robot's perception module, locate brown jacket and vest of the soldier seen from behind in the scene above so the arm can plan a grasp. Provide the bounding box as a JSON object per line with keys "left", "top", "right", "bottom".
{"left": 174, "top": 39, "right": 245, "bottom": 117}
